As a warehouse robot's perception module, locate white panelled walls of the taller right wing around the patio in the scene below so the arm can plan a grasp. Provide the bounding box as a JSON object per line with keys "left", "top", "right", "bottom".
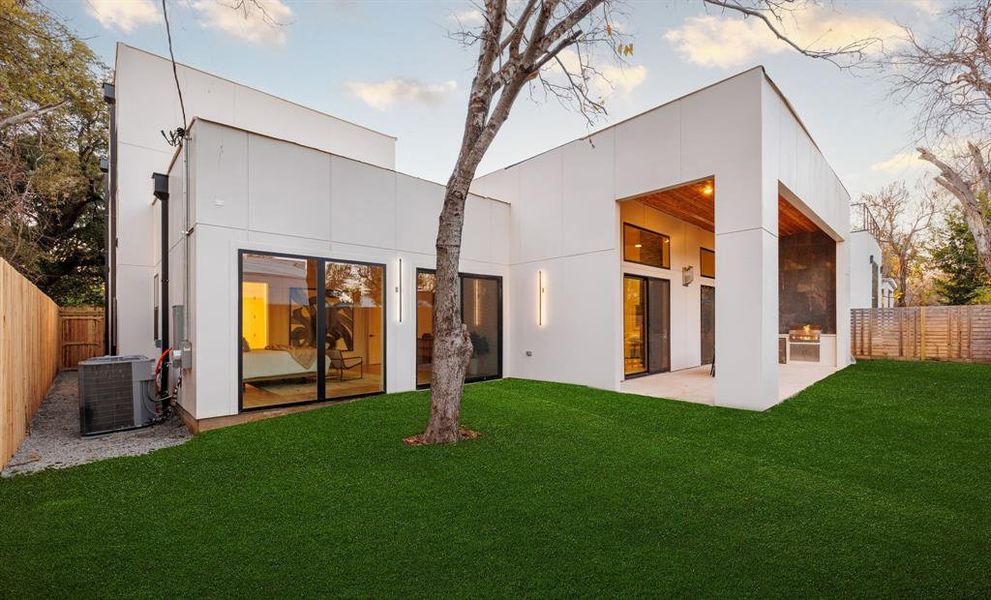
{"left": 473, "top": 68, "right": 849, "bottom": 409}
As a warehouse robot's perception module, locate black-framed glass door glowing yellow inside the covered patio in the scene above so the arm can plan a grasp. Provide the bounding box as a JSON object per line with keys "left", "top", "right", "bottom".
{"left": 623, "top": 275, "right": 671, "bottom": 377}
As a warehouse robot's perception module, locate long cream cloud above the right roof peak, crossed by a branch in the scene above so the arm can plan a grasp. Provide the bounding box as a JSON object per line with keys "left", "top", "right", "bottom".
{"left": 664, "top": 6, "right": 902, "bottom": 68}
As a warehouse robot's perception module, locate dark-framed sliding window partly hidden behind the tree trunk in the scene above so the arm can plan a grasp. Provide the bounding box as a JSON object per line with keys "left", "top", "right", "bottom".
{"left": 416, "top": 270, "right": 502, "bottom": 387}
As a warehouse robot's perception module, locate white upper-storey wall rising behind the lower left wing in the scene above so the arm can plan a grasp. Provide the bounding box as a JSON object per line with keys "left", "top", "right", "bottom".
{"left": 114, "top": 44, "right": 396, "bottom": 356}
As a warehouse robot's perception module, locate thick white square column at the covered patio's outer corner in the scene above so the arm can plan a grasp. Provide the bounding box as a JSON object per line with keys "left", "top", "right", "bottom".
{"left": 715, "top": 171, "right": 778, "bottom": 410}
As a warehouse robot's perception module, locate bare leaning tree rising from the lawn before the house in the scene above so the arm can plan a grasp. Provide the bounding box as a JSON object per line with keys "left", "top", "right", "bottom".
{"left": 407, "top": 0, "right": 852, "bottom": 444}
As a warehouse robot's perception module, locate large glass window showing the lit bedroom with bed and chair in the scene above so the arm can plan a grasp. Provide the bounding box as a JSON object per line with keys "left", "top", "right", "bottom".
{"left": 240, "top": 253, "right": 385, "bottom": 409}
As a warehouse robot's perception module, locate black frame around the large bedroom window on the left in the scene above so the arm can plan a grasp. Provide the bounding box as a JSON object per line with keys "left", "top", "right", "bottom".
{"left": 236, "top": 248, "right": 389, "bottom": 414}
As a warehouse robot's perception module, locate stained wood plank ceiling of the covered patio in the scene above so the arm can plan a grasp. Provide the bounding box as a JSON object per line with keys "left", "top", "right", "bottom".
{"left": 635, "top": 179, "right": 819, "bottom": 237}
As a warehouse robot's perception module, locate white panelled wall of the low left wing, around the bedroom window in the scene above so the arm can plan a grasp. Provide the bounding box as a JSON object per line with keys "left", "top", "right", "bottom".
{"left": 170, "top": 120, "right": 510, "bottom": 419}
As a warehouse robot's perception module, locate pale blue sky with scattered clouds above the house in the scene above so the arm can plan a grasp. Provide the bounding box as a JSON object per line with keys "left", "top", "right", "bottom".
{"left": 43, "top": 0, "right": 951, "bottom": 200}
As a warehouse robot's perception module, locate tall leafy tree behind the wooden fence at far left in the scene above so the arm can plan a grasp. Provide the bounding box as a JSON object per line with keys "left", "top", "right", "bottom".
{"left": 0, "top": 0, "right": 108, "bottom": 304}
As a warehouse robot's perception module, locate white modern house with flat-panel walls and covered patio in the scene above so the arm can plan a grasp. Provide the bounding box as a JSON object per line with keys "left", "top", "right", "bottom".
{"left": 107, "top": 45, "right": 880, "bottom": 426}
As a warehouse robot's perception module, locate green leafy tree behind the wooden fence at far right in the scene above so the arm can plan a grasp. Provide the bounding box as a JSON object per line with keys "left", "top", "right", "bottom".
{"left": 930, "top": 208, "right": 991, "bottom": 305}
